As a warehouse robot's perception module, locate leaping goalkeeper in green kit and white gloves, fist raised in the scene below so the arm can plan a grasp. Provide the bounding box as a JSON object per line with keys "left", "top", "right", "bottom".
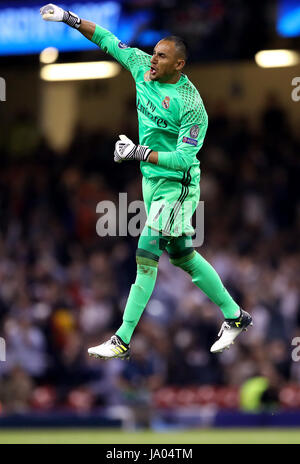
{"left": 40, "top": 4, "right": 252, "bottom": 359}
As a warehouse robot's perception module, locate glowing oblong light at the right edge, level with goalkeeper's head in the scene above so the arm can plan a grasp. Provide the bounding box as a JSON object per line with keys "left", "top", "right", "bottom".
{"left": 255, "top": 50, "right": 300, "bottom": 68}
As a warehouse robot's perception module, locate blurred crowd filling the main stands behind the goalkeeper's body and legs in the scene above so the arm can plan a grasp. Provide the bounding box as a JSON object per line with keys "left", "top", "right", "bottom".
{"left": 0, "top": 92, "right": 300, "bottom": 413}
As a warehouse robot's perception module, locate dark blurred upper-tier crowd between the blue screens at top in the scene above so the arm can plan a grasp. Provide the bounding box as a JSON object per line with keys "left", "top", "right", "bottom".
{"left": 123, "top": 0, "right": 277, "bottom": 61}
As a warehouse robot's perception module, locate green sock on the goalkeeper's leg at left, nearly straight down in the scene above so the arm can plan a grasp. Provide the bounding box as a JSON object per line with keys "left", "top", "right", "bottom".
{"left": 116, "top": 258, "right": 157, "bottom": 344}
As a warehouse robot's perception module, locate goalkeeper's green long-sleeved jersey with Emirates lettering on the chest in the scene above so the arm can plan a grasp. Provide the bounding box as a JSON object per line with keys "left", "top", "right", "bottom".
{"left": 92, "top": 25, "right": 208, "bottom": 185}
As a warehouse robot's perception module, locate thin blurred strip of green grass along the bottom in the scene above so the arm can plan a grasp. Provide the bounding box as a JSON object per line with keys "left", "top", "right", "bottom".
{"left": 0, "top": 428, "right": 300, "bottom": 445}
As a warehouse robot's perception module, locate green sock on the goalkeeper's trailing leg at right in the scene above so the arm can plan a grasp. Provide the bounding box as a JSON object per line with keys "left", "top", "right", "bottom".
{"left": 170, "top": 251, "right": 240, "bottom": 319}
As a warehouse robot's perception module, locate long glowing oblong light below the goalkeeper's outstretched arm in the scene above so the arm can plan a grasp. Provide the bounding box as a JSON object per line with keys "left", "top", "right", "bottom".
{"left": 40, "top": 61, "right": 121, "bottom": 81}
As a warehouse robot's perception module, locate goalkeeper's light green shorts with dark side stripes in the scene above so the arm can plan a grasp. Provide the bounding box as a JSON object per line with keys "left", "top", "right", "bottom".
{"left": 143, "top": 177, "right": 200, "bottom": 237}
